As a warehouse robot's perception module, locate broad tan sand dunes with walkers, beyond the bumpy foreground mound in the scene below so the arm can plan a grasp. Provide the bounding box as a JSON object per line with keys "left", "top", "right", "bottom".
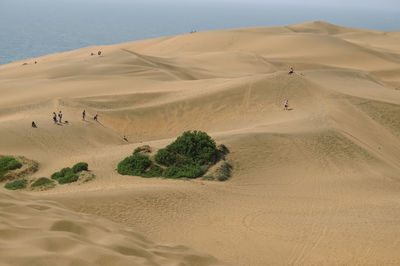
{"left": 0, "top": 21, "right": 400, "bottom": 265}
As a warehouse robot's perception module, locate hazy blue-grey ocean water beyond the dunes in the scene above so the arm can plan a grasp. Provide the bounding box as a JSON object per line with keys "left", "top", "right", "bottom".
{"left": 0, "top": 0, "right": 400, "bottom": 65}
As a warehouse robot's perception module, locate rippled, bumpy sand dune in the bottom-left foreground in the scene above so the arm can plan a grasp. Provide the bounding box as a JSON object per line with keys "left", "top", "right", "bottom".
{"left": 0, "top": 192, "right": 222, "bottom": 265}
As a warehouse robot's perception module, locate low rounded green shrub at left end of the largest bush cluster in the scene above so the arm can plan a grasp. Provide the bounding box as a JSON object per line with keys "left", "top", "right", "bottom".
{"left": 118, "top": 153, "right": 152, "bottom": 176}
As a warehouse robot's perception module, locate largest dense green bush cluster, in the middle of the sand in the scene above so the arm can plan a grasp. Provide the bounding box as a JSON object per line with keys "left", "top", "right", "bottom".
{"left": 117, "top": 131, "right": 227, "bottom": 178}
